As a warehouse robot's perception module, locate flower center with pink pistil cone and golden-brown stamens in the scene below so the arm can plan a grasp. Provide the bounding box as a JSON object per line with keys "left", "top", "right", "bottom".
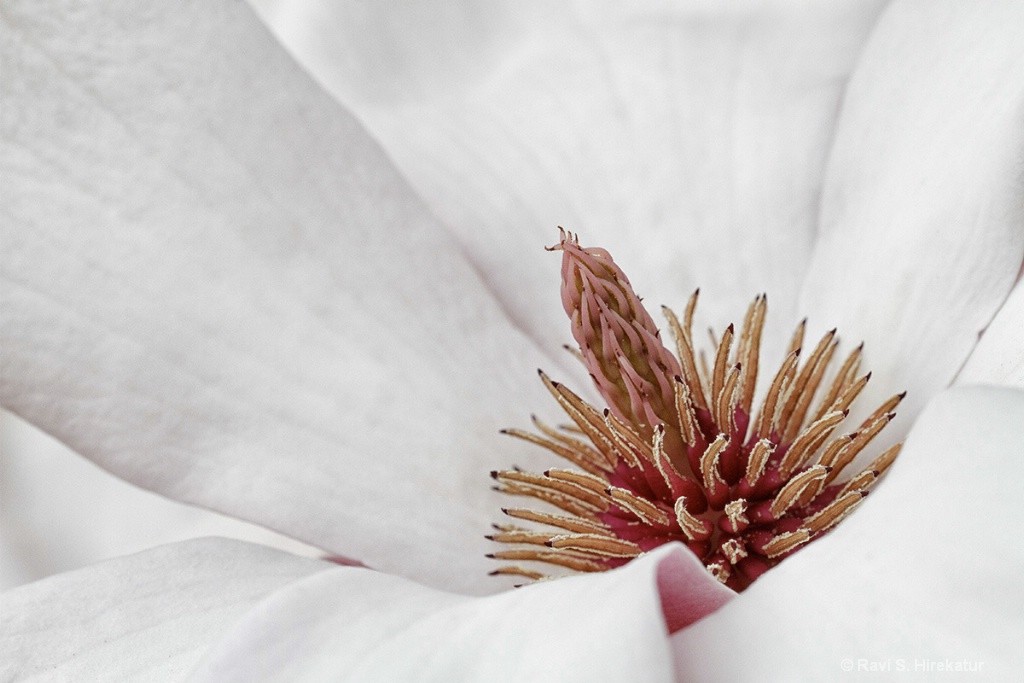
{"left": 487, "top": 231, "right": 905, "bottom": 591}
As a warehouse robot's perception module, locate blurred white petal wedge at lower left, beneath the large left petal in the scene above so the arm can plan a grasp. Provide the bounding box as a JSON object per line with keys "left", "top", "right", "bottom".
{"left": 0, "top": 411, "right": 324, "bottom": 591}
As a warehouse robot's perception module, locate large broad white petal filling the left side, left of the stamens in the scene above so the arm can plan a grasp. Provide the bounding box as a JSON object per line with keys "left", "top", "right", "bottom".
{"left": 0, "top": 0, "right": 558, "bottom": 591}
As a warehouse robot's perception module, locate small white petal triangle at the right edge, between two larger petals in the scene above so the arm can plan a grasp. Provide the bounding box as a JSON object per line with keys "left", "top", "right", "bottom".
{"left": 956, "top": 280, "right": 1024, "bottom": 388}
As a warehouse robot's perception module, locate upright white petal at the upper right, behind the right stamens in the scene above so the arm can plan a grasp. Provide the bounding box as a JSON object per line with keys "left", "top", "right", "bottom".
{"left": 803, "top": 0, "right": 1024, "bottom": 429}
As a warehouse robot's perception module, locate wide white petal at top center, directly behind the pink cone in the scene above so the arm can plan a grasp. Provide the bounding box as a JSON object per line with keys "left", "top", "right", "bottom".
{"left": 256, "top": 0, "right": 882, "bottom": 352}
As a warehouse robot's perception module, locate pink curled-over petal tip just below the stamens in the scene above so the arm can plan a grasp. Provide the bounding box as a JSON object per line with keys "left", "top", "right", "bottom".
{"left": 657, "top": 548, "right": 736, "bottom": 634}
